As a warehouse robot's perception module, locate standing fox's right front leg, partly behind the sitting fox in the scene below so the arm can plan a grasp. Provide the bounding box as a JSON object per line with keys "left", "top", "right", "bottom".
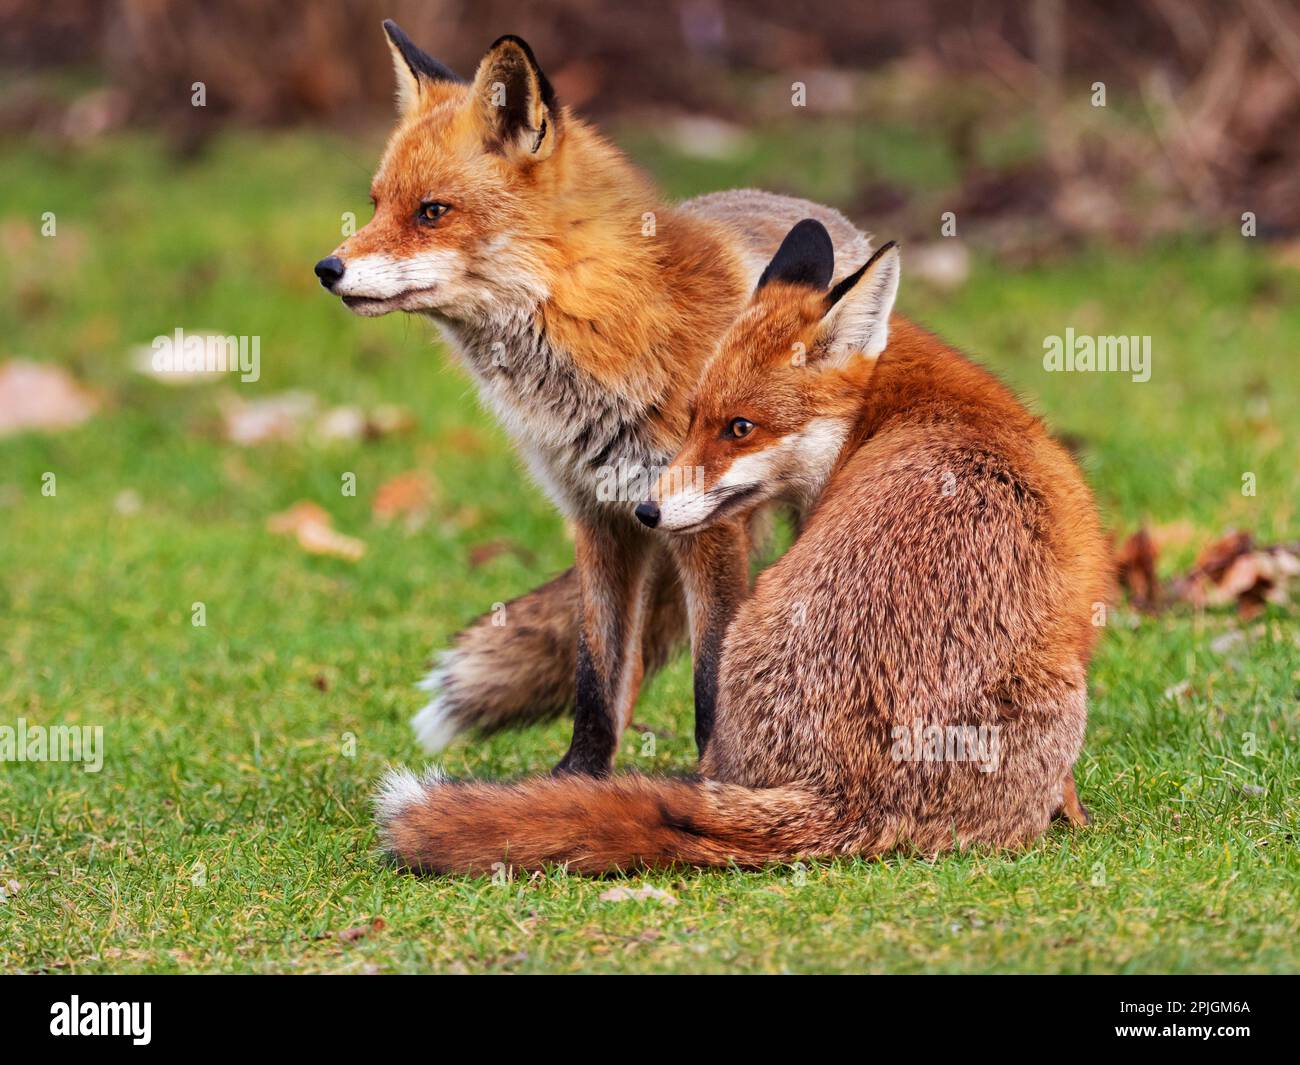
{"left": 671, "top": 521, "right": 749, "bottom": 754}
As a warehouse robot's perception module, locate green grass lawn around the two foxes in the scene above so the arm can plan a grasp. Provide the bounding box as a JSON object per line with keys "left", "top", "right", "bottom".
{"left": 0, "top": 126, "right": 1300, "bottom": 971}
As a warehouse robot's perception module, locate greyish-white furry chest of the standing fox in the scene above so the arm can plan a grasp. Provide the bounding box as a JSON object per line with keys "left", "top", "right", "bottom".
{"left": 447, "top": 315, "right": 672, "bottom": 520}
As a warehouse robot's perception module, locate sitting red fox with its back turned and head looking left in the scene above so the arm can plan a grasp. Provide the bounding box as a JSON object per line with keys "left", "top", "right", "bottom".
{"left": 377, "top": 220, "right": 1109, "bottom": 873}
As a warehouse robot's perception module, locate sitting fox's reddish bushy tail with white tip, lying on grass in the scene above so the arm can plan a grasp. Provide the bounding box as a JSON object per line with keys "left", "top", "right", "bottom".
{"left": 376, "top": 770, "right": 829, "bottom": 874}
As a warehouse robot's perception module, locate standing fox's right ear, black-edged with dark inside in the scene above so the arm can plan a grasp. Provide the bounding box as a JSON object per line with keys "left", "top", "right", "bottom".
{"left": 471, "top": 34, "right": 560, "bottom": 163}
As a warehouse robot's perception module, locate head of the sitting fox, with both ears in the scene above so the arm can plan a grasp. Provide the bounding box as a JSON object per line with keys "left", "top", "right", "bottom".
{"left": 636, "top": 218, "right": 900, "bottom": 533}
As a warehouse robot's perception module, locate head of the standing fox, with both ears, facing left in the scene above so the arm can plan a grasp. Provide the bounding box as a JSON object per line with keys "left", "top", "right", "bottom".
{"left": 316, "top": 21, "right": 566, "bottom": 319}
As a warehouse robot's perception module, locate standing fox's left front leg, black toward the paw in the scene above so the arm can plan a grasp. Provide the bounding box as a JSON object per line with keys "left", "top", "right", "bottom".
{"left": 555, "top": 523, "right": 655, "bottom": 776}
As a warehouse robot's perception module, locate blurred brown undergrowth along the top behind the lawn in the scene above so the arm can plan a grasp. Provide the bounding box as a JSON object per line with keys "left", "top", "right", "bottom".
{"left": 0, "top": 0, "right": 1300, "bottom": 248}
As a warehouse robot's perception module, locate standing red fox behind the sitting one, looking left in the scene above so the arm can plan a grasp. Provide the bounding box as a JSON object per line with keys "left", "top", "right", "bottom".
{"left": 316, "top": 22, "right": 870, "bottom": 774}
